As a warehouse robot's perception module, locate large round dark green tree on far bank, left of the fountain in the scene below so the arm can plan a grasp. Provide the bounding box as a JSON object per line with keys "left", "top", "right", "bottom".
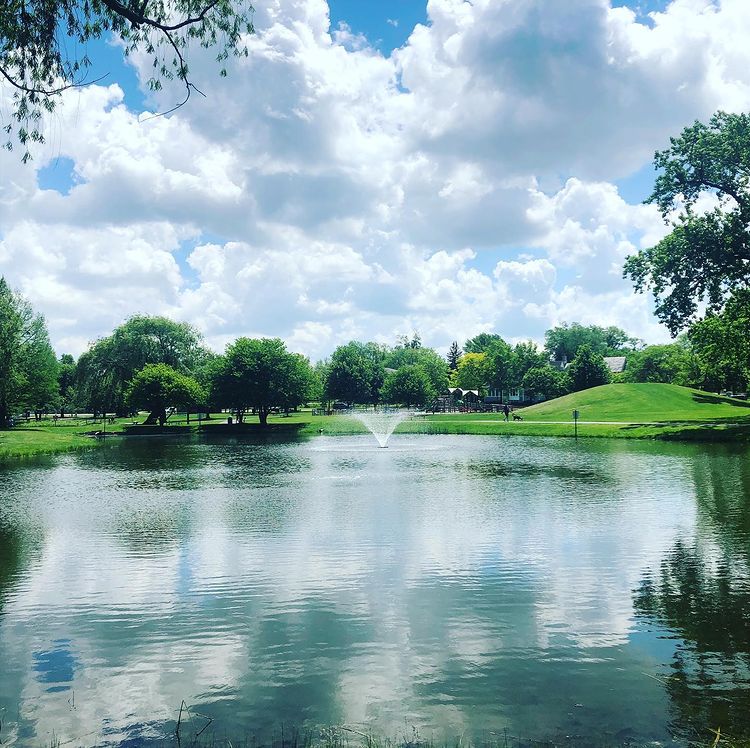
{"left": 212, "top": 338, "right": 312, "bottom": 426}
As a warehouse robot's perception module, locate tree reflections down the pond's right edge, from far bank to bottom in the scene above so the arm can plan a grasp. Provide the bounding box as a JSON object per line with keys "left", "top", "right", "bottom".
{"left": 634, "top": 446, "right": 750, "bottom": 740}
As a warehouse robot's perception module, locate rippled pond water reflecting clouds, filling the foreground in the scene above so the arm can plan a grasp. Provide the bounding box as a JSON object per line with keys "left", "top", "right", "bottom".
{"left": 0, "top": 435, "right": 750, "bottom": 745}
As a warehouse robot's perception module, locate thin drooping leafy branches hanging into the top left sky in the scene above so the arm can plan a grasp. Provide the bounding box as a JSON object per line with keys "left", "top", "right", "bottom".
{"left": 0, "top": 0, "right": 253, "bottom": 161}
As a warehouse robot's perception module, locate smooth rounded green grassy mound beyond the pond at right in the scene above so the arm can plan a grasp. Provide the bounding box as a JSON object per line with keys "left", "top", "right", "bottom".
{"left": 523, "top": 384, "right": 750, "bottom": 423}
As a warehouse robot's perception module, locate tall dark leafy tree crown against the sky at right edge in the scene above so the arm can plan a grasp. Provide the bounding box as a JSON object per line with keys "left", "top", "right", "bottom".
{"left": 623, "top": 112, "right": 750, "bottom": 335}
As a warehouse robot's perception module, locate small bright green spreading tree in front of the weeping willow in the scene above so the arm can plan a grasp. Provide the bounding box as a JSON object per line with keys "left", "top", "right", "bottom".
{"left": 126, "top": 364, "right": 204, "bottom": 426}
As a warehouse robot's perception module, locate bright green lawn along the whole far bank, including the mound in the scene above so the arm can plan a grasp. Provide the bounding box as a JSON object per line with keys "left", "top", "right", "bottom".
{"left": 0, "top": 384, "right": 750, "bottom": 463}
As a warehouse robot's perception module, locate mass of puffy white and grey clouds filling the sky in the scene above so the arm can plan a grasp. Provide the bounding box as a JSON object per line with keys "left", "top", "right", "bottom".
{"left": 0, "top": 0, "right": 750, "bottom": 358}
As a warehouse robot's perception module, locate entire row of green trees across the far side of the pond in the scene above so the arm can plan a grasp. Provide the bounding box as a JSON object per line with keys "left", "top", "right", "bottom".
{"left": 0, "top": 278, "right": 750, "bottom": 425}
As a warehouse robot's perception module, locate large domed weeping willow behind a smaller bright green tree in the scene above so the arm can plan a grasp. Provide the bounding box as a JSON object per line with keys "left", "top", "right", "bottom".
{"left": 76, "top": 316, "right": 206, "bottom": 415}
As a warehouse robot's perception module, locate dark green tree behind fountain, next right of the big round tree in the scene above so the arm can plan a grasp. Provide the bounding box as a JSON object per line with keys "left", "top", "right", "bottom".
{"left": 325, "top": 340, "right": 385, "bottom": 404}
